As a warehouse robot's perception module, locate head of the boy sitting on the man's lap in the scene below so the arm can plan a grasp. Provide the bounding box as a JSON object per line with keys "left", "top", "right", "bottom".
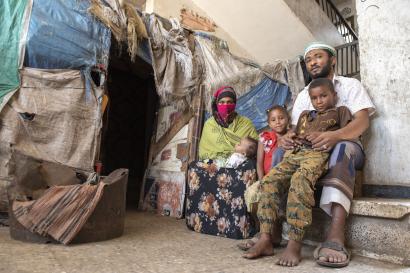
{"left": 309, "top": 78, "right": 337, "bottom": 112}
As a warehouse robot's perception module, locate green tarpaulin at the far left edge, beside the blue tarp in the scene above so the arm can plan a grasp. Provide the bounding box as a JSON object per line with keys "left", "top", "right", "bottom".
{"left": 0, "top": 0, "right": 30, "bottom": 111}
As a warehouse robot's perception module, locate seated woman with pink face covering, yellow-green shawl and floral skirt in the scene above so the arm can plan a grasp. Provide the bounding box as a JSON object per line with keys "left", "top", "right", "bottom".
{"left": 185, "top": 86, "right": 258, "bottom": 239}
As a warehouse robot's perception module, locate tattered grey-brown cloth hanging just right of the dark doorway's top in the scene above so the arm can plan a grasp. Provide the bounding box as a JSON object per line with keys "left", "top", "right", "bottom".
{"left": 148, "top": 14, "right": 202, "bottom": 110}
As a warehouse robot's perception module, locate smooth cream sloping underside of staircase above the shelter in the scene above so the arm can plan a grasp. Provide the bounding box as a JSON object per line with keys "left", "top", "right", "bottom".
{"left": 192, "top": 0, "right": 315, "bottom": 64}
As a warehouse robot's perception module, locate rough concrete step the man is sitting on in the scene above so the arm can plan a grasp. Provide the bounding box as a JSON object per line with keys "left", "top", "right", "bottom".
{"left": 305, "top": 198, "right": 410, "bottom": 265}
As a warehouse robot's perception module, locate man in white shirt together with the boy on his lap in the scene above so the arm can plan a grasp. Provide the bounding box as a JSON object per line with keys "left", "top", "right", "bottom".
{"left": 244, "top": 42, "right": 375, "bottom": 267}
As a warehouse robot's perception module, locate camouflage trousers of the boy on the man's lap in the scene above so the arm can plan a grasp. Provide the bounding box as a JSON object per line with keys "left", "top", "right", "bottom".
{"left": 257, "top": 148, "right": 329, "bottom": 241}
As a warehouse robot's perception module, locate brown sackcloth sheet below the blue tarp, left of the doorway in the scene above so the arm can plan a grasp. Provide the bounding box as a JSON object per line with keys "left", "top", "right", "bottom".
{"left": 0, "top": 68, "right": 102, "bottom": 173}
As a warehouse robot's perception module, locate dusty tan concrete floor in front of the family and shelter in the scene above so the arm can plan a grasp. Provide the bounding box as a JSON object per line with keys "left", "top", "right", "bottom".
{"left": 0, "top": 211, "right": 410, "bottom": 273}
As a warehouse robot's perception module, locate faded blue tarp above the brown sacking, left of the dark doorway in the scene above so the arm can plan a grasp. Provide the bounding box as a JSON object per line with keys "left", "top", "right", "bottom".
{"left": 25, "top": 0, "right": 111, "bottom": 69}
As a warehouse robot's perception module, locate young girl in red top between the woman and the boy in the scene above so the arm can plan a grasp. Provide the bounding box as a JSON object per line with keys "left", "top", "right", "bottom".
{"left": 257, "top": 105, "right": 289, "bottom": 179}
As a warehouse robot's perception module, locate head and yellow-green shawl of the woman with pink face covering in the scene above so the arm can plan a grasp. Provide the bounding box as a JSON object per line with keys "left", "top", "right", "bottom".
{"left": 199, "top": 86, "right": 258, "bottom": 162}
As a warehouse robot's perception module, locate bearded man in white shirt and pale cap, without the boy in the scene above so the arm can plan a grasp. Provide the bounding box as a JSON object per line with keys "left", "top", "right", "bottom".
{"left": 244, "top": 42, "right": 375, "bottom": 267}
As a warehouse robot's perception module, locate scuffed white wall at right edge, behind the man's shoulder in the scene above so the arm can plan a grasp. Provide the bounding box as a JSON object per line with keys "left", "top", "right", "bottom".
{"left": 356, "top": 0, "right": 410, "bottom": 186}
